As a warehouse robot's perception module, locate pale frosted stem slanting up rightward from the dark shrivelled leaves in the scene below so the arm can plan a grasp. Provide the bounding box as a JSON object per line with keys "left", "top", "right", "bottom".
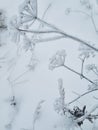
{"left": 76, "top": 104, "right": 98, "bottom": 123}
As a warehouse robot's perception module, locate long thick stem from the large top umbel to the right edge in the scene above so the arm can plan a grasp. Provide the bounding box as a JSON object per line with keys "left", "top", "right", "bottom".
{"left": 37, "top": 18, "right": 98, "bottom": 52}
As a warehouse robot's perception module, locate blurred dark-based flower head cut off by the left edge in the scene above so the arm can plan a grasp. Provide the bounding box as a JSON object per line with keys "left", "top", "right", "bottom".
{"left": 0, "top": 9, "right": 7, "bottom": 29}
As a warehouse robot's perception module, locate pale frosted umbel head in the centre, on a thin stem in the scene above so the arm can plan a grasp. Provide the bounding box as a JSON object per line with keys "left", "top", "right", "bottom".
{"left": 49, "top": 50, "right": 66, "bottom": 70}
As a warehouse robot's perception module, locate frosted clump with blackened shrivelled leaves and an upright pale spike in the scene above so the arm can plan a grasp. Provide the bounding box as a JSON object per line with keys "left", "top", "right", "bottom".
{"left": 54, "top": 79, "right": 98, "bottom": 129}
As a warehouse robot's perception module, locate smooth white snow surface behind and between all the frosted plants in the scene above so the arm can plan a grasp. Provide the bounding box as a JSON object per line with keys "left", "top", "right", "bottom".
{"left": 0, "top": 0, "right": 98, "bottom": 130}
